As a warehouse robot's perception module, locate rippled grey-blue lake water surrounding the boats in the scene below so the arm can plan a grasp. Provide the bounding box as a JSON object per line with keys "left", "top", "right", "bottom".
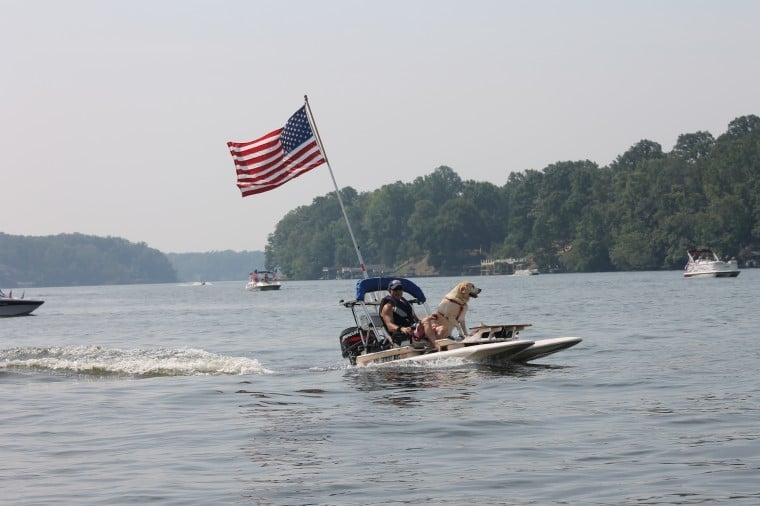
{"left": 0, "top": 269, "right": 760, "bottom": 505}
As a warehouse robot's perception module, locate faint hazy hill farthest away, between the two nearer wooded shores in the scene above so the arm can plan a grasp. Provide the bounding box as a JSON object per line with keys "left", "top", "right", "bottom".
{"left": 166, "top": 250, "right": 265, "bottom": 281}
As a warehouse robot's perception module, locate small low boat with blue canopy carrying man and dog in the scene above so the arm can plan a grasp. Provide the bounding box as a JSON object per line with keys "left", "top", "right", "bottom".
{"left": 339, "top": 277, "right": 582, "bottom": 366}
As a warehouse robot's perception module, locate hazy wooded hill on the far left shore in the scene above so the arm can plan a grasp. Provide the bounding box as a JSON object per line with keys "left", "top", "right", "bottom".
{"left": 0, "top": 232, "right": 177, "bottom": 288}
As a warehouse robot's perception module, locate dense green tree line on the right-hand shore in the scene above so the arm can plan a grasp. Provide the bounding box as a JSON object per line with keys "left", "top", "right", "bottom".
{"left": 265, "top": 115, "right": 760, "bottom": 279}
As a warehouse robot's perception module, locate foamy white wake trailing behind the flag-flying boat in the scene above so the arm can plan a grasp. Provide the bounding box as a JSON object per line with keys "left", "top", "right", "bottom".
{"left": 0, "top": 346, "right": 271, "bottom": 378}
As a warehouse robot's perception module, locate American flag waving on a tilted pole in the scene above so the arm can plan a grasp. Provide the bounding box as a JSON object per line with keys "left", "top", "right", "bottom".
{"left": 227, "top": 106, "right": 325, "bottom": 197}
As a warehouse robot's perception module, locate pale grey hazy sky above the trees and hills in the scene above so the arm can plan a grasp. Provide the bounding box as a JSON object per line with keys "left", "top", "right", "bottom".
{"left": 0, "top": 0, "right": 760, "bottom": 256}
